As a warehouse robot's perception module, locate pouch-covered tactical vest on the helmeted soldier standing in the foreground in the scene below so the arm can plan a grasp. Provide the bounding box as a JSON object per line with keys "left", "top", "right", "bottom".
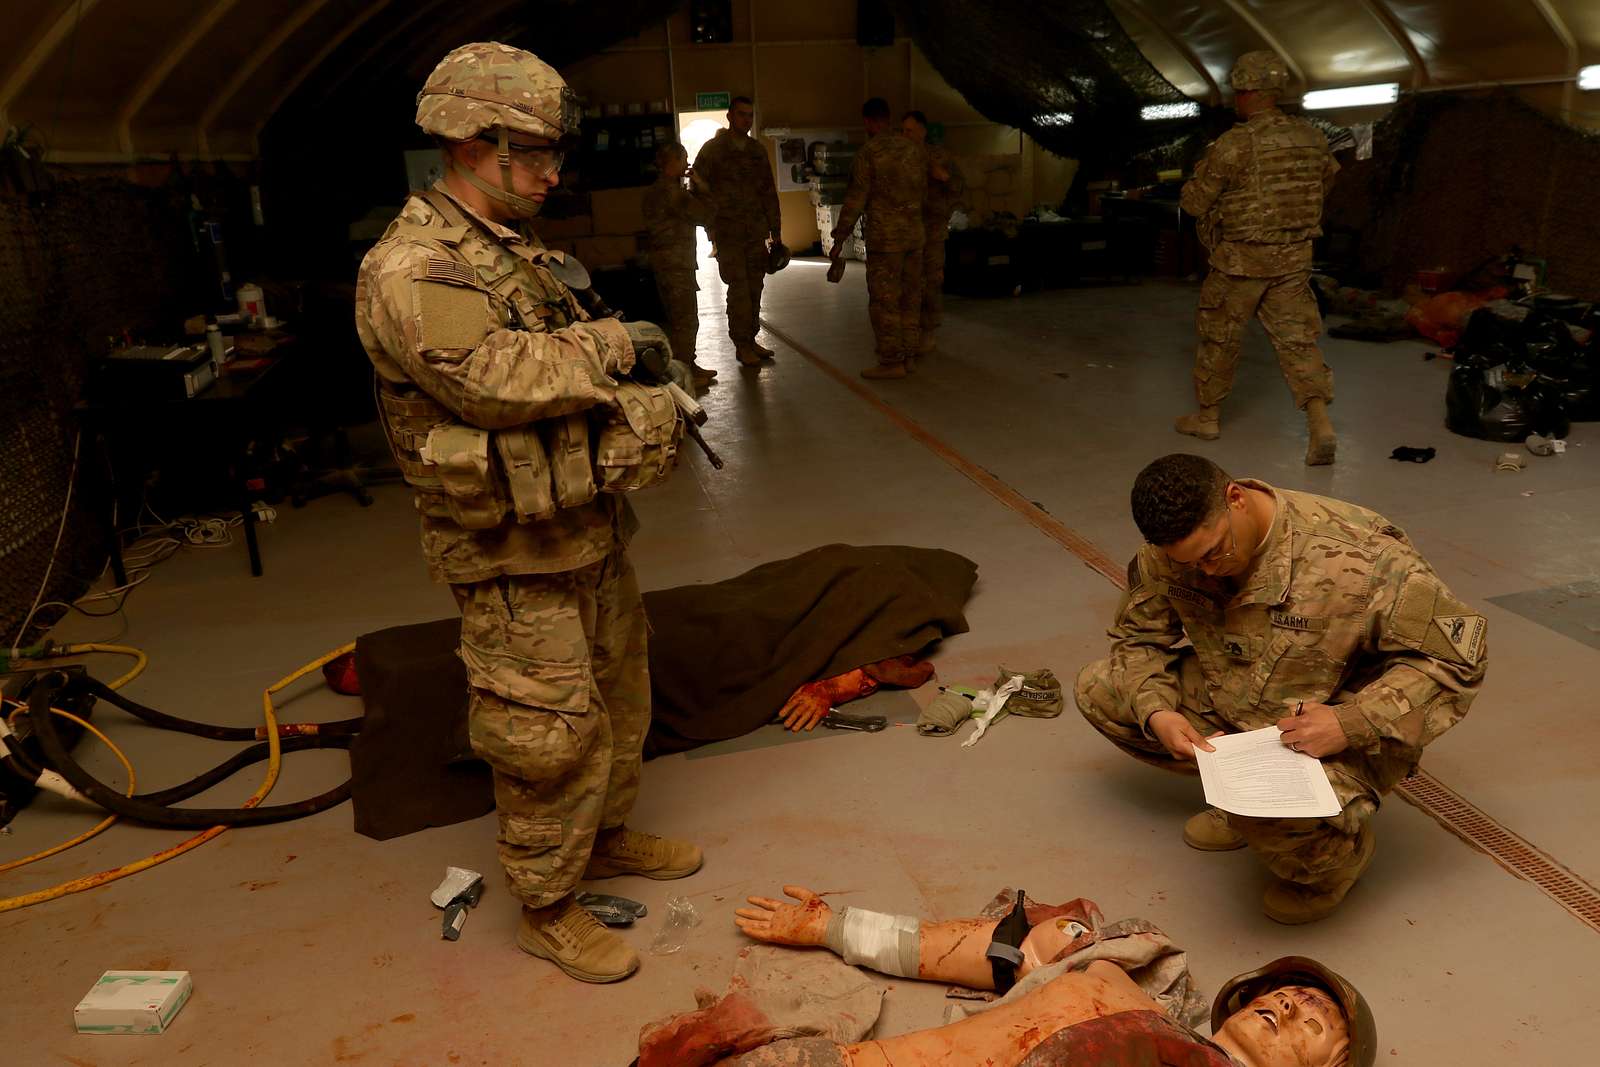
{"left": 378, "top": 189, "right": 682, "bottom": 530}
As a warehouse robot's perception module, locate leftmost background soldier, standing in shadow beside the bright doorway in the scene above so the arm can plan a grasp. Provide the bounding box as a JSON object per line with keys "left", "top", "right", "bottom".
{"left": 645, "top": 142, "right": 717, "bottom": 386}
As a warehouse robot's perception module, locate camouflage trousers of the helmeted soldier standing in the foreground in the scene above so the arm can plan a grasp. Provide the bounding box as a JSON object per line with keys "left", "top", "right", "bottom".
{"left": 451, "top": 549, "right": 650, "bottom": 907}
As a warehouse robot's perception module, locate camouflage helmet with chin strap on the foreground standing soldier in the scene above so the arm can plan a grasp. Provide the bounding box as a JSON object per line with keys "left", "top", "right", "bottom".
{"left": 416, "top": 42, "right": 579, "bottom": 214}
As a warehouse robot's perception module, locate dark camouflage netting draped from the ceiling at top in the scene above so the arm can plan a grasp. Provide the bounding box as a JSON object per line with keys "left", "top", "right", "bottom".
{"left": 894, "top": 0, "right": 1229, "bottom": 173}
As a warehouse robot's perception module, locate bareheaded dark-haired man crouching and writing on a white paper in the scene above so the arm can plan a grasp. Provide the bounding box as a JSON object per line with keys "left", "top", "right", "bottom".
{"left": 1077, "top": 454, "right": 1488, "bottom": 923}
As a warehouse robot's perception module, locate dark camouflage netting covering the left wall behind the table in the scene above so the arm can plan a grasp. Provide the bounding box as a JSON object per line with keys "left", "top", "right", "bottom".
{"left": 0, "top": 181, "right": 194, "bottom": 646}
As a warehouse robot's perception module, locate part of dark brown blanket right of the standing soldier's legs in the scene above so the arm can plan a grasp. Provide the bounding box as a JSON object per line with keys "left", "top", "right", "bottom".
{"left": 645, "top": 544, "right": 978, "bottom": 758}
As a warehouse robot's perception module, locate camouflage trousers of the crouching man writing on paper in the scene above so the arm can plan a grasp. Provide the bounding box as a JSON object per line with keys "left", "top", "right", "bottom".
{"left": 1077, "top": 651, "right": 1378, "bottom": 889}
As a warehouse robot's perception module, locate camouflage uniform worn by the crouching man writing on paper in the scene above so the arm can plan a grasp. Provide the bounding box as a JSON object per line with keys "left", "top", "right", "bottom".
{"left": 1077, "top": 480, "right": 1486, "bottom": 888}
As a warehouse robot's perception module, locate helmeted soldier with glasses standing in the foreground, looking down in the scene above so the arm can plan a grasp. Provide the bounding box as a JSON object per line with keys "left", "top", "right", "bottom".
{"left": 355, "top": 43, "right": 701, "bottom": 982}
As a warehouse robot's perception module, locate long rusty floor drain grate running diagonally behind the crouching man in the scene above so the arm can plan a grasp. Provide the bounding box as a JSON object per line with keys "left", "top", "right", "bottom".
{"left": 762, "top": 318, "right": 1600, "bottom": 933}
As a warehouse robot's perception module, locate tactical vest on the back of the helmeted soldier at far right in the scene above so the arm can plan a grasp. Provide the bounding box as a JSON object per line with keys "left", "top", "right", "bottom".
{"left": 1218, "top": 115, "right": 1328, "bottom": 245}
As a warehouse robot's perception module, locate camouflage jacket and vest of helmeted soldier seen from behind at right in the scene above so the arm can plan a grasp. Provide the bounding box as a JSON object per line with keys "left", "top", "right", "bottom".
{"left": 1181, "top": 107, "right": 1339, "bottom": 278}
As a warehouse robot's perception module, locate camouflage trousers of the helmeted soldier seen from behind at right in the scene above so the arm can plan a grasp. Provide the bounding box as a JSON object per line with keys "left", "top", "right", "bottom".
{"left": 1195, "top": 270, "right": 1333, "bottom": 408}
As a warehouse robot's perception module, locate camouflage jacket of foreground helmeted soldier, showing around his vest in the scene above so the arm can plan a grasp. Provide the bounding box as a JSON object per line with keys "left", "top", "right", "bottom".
{"left": 355, "top": 182, "right": 634, "bottom": 582}
